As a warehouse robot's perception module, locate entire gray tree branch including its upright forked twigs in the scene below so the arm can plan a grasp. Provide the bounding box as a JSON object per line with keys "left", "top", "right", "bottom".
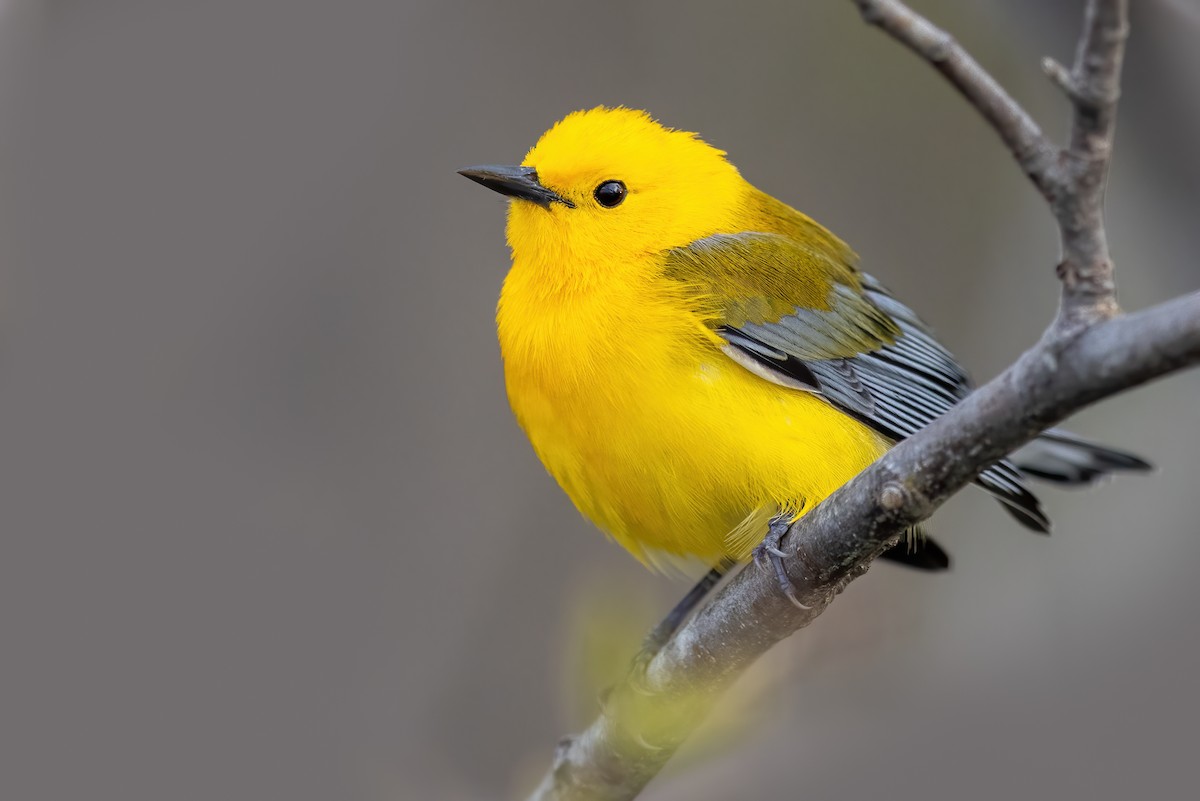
{"left": 530, "top": 0, "right": 1200, "bottom": 801}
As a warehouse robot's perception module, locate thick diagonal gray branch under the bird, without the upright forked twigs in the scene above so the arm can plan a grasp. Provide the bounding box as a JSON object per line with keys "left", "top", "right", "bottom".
{"left": 532, "top": 293, "right": 1200, "bottom": 801}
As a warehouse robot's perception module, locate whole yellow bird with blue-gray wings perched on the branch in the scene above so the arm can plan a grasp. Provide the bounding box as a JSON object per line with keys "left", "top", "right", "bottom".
{"left": 460, "top": 106, "right": 1151, "bottom": 601}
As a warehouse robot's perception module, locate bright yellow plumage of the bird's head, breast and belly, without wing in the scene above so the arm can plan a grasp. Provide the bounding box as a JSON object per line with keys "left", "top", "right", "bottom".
{"left": 497, "top": 109, "right": 887, "bottom": 564}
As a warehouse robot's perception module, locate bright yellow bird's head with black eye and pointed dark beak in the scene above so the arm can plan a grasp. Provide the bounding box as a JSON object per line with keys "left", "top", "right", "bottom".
{"left": 461, "top": 107, "right": 748, "bottom": 261}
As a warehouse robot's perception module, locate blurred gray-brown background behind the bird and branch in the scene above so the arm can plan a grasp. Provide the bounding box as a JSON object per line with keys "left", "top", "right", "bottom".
{"left": 0, "top": 0, "right": 1200, "bottom": 801}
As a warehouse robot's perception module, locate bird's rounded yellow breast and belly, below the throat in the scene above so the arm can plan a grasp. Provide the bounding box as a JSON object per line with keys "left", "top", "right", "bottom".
{"left": 500, "top": 281, "right": 888, "bottom": 567}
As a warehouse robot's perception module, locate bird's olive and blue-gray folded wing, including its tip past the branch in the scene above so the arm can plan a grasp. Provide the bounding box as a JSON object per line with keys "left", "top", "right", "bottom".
{"left": 665, "top": 231, "right": 1050, "bottom": 531}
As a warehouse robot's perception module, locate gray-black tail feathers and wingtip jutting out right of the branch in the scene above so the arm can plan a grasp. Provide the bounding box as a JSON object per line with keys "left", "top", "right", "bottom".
{"left": 976, "top": 428, "right": 1153, "bottom": 534}
